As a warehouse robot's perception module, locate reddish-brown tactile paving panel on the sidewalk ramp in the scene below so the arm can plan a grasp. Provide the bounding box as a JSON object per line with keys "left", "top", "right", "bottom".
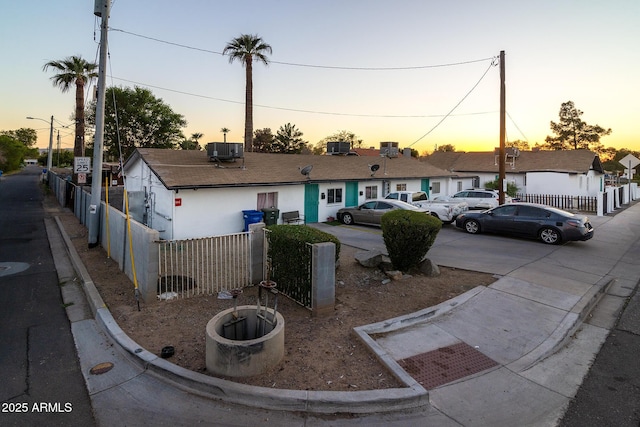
{"left": 398, "top": 343, "right": 498, "bottom": 390}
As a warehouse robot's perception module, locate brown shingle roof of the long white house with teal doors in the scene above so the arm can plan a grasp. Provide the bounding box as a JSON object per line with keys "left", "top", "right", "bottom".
{"left": 125, "top": 148, "right": 456, "bottom": 189}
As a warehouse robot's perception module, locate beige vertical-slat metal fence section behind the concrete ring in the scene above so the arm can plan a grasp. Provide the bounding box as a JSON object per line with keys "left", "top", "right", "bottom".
{"left": 158, "top": 233, "right": 251, "bottom": 299}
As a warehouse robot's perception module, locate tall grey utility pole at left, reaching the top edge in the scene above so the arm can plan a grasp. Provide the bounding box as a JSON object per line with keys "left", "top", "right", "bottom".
{"left": 88, "top": 0, "right": 111, "bottom": 248}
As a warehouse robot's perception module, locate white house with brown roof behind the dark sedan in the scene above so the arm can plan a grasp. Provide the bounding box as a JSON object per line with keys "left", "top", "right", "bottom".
{"left": 425, "top": 149, "right": 605, "bottom": 196}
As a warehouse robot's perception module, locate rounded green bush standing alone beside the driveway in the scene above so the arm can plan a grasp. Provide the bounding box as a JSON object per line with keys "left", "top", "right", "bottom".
{"left": 381, "top": 209, "right": 442, "bottom": 271}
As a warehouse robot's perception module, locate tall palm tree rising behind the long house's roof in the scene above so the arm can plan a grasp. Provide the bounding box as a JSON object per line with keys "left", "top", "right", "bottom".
{"left": 222, "top": 34, "right": 272, "bottom": 151}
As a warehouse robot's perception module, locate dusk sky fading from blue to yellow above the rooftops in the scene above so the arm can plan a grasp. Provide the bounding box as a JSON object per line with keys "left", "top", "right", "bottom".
{"left": 0, "top": 0, "right": 640, "bottom": 153}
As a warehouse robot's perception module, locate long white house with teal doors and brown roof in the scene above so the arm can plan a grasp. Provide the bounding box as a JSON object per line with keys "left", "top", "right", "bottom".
{"left": 124, "top": 148, "right": 466, "bottom": 240}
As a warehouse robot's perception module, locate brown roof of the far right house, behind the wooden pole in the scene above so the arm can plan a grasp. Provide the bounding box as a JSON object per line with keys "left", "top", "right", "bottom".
{"left": 425, "top": 150, "right": 604, "bottom": 173}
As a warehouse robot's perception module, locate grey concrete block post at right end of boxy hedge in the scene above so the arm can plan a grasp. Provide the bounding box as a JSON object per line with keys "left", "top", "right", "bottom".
{"left": 311, "top": 242, "right": 336, "bottom": 316}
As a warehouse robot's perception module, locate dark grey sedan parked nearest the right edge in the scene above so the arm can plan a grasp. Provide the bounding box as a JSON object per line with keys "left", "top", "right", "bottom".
{"left": 456, "top": 203, "right": 594, "bottom": 245}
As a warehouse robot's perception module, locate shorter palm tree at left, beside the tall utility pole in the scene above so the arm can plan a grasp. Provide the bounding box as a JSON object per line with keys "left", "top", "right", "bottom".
{"left": 42, "top": 56, "right": 98, "bottom": 157}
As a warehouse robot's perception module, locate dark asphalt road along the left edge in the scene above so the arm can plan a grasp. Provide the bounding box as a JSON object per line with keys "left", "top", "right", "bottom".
{"left": 0, "top": 166, "right": 95, "bottom": 426}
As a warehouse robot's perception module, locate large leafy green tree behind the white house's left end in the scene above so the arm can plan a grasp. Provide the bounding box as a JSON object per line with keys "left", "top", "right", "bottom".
{"left": 89, "top": 87, "right": 187, "bottom": 159}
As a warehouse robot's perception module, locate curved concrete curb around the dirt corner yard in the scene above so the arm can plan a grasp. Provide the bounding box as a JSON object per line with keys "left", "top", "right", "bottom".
{"left": 55, "top": 217, "right": 429, "bottom": 414}
